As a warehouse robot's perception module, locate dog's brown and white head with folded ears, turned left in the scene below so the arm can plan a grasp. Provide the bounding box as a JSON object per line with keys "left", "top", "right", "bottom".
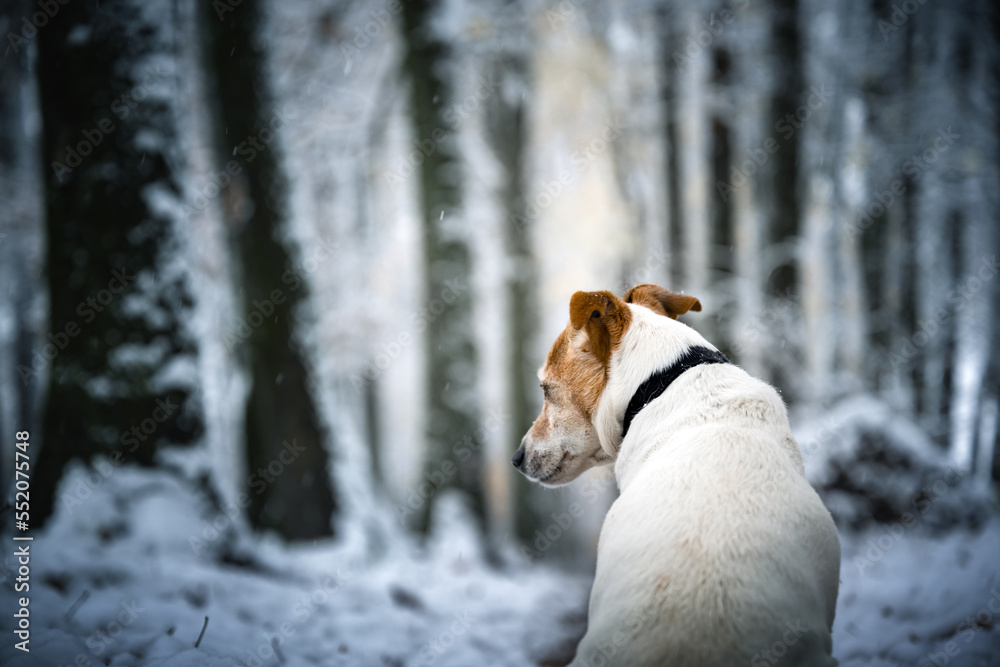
{"left": 512, "top": 285, "right": 701, "bottom": 486}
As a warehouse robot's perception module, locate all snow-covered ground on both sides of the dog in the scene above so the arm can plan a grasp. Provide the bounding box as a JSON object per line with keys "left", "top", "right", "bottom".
{"left": 0, "top": 460, "right": 1000, "bottom": 667}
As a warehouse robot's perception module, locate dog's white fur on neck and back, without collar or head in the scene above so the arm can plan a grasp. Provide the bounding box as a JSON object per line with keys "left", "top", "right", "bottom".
{"left": 571, "top": 304, "right": 840, "bottom": 667}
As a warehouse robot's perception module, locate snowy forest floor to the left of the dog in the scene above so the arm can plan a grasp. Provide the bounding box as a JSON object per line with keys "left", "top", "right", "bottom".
{"left": 0, "top": 466, "right": 588, "bottom": 667}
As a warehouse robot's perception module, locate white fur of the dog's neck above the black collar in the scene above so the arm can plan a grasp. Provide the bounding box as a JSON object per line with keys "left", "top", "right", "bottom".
{"left": 594, "top": 304, "right": 715, "bottom": 482}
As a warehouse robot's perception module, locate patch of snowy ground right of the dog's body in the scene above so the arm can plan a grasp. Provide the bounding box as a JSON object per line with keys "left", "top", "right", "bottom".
{"left": 833, "top": 520, "right": 1000, "bottom": 667}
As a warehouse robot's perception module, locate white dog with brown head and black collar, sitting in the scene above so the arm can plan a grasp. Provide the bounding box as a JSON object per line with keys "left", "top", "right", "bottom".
{"left": 512, "top": 285, "right": 840, "bottom": 667}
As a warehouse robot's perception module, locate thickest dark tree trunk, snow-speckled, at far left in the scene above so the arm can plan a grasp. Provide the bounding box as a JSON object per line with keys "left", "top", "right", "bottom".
{"left": 32, "top": 0, "right": 201, "bottom": 521}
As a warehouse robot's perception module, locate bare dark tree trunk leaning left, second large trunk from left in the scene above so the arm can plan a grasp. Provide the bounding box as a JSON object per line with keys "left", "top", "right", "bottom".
{"left": 203, "top": 0, "right": 338, "bottom": 540}
